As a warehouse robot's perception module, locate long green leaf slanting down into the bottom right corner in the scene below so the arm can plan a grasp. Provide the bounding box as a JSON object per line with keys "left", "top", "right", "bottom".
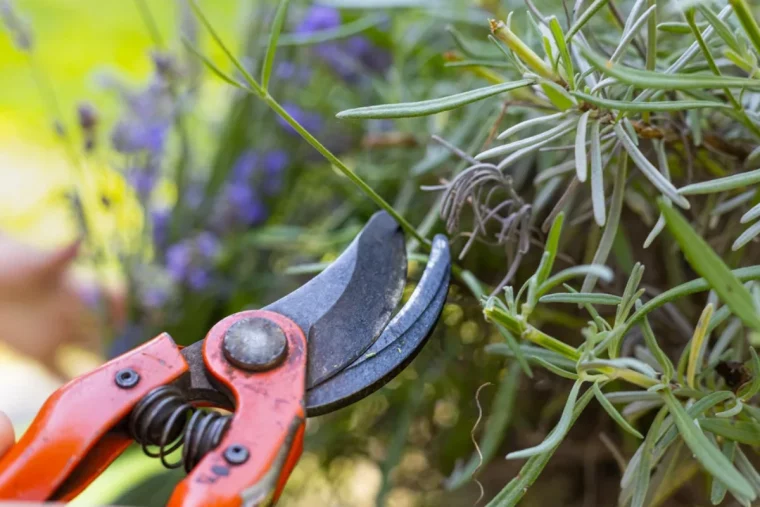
{"left": 663, "top": 390, "right": 757, "bottom": 500}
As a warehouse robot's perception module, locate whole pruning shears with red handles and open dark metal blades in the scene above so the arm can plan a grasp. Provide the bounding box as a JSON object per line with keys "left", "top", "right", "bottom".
{"left": 0, "top": 212, "right": 451, "bottom": 506}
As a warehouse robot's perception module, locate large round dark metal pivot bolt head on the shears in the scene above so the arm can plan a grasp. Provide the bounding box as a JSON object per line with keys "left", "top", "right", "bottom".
{"left": 222, "top": 317, "right": 288, "bottom": 371}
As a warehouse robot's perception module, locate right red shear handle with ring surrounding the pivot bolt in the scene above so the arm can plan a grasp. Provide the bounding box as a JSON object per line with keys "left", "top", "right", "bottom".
{"left": 169, "top": 311, "right": 306, "bottom": 507}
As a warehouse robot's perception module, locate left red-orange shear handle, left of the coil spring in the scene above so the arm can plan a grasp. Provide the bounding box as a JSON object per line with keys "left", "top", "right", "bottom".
{"left": 0, "top": 333, "right": 188, "bottom": 502}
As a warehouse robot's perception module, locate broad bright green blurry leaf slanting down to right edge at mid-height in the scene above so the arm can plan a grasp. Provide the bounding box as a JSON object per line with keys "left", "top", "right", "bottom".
{"left": 658, "top": 200, "right": 760, "bottom": 331}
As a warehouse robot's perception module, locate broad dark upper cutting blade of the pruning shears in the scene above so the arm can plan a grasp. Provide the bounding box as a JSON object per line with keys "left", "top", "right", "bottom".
{"left": 263, "top": 212, "right": 406, "bottom": 389}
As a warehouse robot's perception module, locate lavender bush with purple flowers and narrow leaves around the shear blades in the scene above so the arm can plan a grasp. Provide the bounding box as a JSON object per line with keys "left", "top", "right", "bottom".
{"left": 7, "top": 0, "right": 760, "bottom": 506}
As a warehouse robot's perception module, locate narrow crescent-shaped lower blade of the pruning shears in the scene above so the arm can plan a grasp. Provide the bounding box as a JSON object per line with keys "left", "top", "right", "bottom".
{"left": 306, "top": 235, "right": 451, "bottom": 417}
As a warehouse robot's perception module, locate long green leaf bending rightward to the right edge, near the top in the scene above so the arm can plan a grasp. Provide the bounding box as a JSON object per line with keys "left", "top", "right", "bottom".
{"left": 579, "top": 45, "right": 760, "bottom": 91}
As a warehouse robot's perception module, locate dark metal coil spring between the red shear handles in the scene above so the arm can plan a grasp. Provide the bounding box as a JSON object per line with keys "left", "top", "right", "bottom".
{"left": 129, "top": 386, "right": 232, "bottom": 473}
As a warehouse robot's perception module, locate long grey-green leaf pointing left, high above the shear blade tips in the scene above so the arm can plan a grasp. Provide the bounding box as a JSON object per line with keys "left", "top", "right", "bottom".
{"left": 336, "top": 79, "right": 533, "bottom": 119}
